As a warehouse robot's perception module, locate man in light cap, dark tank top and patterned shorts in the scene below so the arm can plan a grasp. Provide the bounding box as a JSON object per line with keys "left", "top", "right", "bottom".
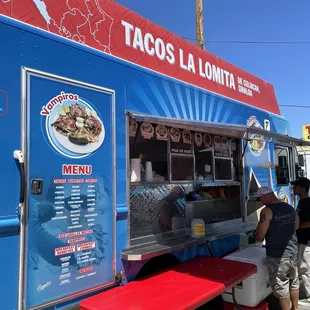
{"left": 255, "top": 186, "right": 299, "bottom": 310}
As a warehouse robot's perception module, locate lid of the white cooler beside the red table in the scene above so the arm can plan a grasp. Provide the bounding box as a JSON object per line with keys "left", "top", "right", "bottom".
{"left": 223, "top": 246, "right": 266, "bottom": 267}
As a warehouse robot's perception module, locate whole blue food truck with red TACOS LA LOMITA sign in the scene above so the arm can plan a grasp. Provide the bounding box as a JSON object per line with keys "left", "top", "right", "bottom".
{"left": 0, "top": 1, "right": 308, "bottom": 310}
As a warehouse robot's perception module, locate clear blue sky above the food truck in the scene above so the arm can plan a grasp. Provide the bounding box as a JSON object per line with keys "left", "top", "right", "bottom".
{"left": 116, "top": 0, "right": 310, "bottom": 137}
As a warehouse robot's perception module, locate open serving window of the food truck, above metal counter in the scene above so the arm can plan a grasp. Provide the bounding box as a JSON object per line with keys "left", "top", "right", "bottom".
{"left": 128, "top": 118, "right": 243, "bottom": 242}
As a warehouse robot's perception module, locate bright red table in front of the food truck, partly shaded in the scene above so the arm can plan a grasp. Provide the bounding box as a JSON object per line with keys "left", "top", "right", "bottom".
{"left": 80, "top": 257, "right": 257, "bottom": 310}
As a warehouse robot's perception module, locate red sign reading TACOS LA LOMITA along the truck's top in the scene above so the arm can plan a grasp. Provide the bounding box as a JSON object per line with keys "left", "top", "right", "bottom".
{"left": 0, "top": 0, "right": 280, "bottom": 114}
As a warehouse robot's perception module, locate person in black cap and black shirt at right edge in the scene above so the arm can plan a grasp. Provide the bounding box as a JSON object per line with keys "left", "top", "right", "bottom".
{"left": 291, "top": 178, "right": 310, "bottom": 307}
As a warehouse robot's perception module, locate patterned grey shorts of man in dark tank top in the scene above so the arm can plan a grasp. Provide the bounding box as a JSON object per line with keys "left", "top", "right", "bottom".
{"left": 267, "top": 255, "right": 299, "bottom": 298}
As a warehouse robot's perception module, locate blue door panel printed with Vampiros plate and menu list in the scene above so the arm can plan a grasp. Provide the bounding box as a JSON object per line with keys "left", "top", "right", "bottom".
{"left": 26, "top": 76, "right": 115, "bottom": 308}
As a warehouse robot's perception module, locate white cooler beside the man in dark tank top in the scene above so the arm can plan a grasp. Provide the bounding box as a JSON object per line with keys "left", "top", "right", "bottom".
{"left": 222, "top": 246, "right": 272, "bottom": 307}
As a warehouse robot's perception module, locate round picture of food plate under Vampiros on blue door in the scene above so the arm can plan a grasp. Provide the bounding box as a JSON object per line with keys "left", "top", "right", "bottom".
{"left": 46, "top": 98, "right": 105, "bottom": 154}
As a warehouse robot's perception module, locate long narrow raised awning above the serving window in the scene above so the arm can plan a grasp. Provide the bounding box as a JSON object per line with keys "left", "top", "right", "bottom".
{"left": 127, "top": 111, "right": 310, "bottom": 146}
